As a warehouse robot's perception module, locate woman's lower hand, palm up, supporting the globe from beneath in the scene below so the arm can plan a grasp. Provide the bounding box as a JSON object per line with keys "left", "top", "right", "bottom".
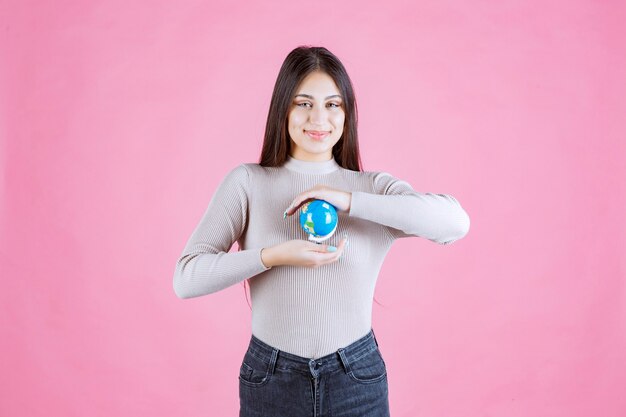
{"left": 261, "top": 236, "right": 348, "bottom": 268}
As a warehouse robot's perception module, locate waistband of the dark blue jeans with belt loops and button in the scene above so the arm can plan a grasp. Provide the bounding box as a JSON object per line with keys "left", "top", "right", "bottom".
{"left": 248, "top": 329, "right": 378, "bottom": 376}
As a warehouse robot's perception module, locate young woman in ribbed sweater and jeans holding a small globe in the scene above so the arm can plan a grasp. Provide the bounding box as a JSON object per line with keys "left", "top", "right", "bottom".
{"left": 174, "top": 47, "right": 470, "bottom": 417}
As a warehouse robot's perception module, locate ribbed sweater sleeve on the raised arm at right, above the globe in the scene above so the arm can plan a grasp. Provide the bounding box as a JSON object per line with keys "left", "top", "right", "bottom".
{"left": 349, "top": 172, "right": 470, "bottom": 245}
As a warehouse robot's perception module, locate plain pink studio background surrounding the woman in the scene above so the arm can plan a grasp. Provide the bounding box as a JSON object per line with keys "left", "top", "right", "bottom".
{"left": 0, "top": 0, "right": 626, "bottom": 417}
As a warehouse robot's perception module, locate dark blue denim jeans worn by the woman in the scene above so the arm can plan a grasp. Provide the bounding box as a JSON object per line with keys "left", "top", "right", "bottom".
{"left": 239, "top": 329, "right": 389, "bottom": 417}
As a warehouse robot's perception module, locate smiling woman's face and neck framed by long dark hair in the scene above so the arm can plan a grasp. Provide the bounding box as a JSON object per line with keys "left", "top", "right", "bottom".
{"left": 288, "top": 71, "right": 345, "bottom": 161}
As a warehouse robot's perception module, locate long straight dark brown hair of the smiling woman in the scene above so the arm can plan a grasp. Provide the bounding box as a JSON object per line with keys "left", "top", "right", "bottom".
{"left": 259, "top": 46, "right": 363, "bottom": 171}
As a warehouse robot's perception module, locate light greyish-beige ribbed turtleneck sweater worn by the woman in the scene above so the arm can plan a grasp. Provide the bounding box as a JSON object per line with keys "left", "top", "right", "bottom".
{"left": 174, "top": 158, "right": 470, "bottom": 359}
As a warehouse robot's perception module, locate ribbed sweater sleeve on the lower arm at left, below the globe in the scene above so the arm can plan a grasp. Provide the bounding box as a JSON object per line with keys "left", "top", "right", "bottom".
{"left": 174, "top": 164, "right": 270, "bottom": 298}
